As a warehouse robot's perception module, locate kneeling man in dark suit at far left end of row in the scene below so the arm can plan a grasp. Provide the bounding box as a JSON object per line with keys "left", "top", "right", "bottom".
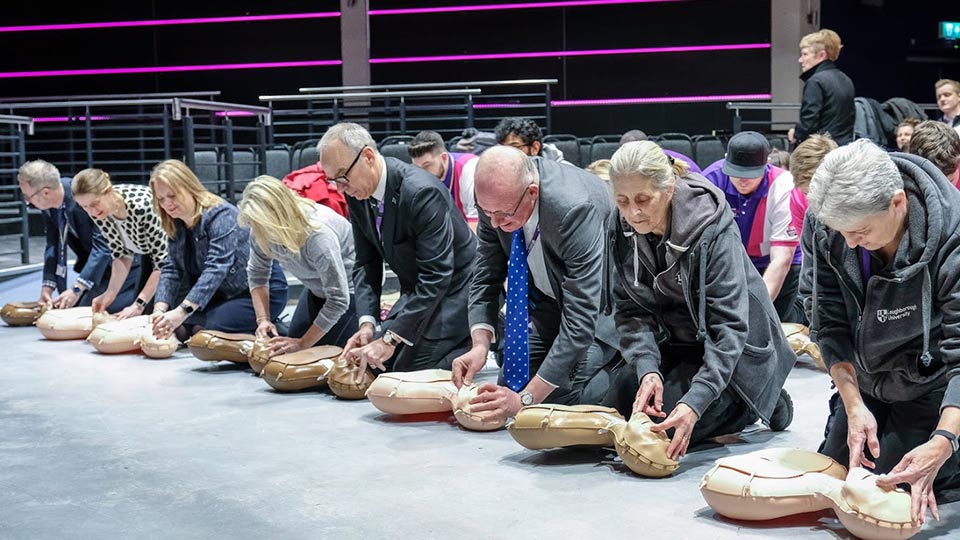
{"left": 17, "top": 159, "right": 139, "bottom": 313}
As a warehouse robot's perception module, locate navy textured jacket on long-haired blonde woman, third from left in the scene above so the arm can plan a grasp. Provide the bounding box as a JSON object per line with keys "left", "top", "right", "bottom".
{"left": 156, "top": 201, "right": 256, "bottom": 309}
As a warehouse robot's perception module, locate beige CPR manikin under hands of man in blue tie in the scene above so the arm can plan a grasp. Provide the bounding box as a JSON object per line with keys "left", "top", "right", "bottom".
{"left": 367, "top": 369, "right": 505, "bottom": 431}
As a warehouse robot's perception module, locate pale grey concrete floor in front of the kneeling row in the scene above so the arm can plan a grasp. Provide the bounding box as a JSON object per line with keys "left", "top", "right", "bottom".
{"left": 0, "top": 275, "right": 960, "bottom": 540}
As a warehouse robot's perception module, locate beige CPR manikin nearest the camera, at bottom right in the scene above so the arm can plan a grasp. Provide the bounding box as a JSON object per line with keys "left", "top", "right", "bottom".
{"left": 700, "top": 448, "right": 920, "bottom": 540}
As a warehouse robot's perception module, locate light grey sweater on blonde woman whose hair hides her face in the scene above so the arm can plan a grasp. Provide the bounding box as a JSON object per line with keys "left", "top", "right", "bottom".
{"left": 247, "top": 204, "right": 355, "bottom": 332}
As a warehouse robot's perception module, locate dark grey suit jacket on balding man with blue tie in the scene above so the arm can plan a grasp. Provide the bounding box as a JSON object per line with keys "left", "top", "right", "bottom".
{"left": 470, "top": 157, "right": 618, "bottom": 389}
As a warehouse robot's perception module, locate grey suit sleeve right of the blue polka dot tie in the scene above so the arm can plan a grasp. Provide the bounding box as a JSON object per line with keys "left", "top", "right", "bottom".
{"left": 537, "top": 204, "right": 607, "bottom": 389}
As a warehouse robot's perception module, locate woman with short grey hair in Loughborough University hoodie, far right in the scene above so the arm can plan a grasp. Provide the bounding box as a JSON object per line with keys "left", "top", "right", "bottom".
{"left": 802, "top": 139, "right": 960, "bottom": 523}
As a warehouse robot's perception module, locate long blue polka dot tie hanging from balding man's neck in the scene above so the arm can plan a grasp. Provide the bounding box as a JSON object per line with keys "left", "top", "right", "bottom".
{"left": 503, "top": 228, "right": 530, "bottom": 392}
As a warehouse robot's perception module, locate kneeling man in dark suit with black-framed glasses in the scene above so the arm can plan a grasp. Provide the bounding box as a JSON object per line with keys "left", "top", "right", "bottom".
{"left": 318, "top": 123, "right": 477, "bottom": 371}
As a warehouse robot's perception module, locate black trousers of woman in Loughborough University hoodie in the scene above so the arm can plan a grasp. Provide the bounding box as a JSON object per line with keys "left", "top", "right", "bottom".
{"left": 818, "top": 388, "right": 960, "bottom": 503}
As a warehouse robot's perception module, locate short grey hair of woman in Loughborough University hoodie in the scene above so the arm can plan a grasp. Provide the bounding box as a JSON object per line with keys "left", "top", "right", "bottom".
{"left": 807, "top": 139, "right": 903, "bottom": 230}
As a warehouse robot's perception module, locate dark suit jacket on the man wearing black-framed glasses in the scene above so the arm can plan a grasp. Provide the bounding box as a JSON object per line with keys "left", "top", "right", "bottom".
{"left": 347, "top": 157, "right": 477, "bottom": 346}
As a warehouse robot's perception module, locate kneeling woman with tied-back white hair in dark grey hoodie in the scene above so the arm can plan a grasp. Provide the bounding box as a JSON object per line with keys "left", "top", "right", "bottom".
{"left": 609, "top": 141, "right": 796, "bottom": 458}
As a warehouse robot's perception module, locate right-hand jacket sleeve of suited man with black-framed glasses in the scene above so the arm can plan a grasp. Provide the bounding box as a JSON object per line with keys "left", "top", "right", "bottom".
{"left": 390, "top": 184, "right": 464, "bottom": 343}
